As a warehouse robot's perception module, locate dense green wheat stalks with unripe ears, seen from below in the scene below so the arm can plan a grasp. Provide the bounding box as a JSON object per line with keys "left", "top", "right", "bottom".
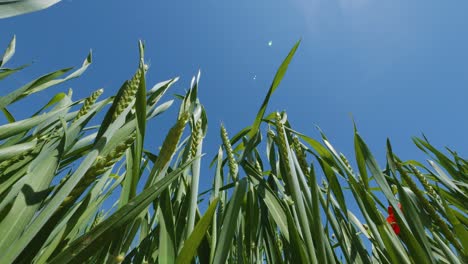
{"left": 0, "top": 38, "right": 468, "bottom": 264}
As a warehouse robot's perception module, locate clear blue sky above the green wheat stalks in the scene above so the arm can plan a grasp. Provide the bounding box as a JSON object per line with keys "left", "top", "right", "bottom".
{"left": 0, "top": 0, "right": 468, "bottom": 194}
